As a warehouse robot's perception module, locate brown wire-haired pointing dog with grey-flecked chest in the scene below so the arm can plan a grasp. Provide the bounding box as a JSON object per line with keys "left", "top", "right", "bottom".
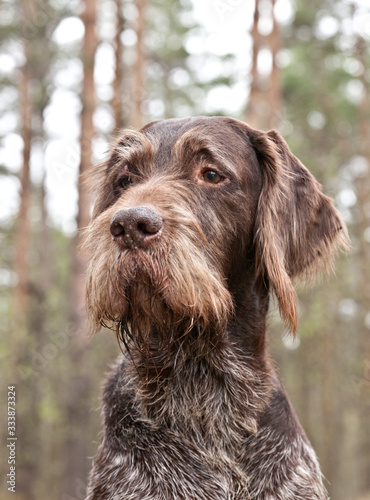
{"left": 85, "top": 117, "right": 347, "bottom": 500}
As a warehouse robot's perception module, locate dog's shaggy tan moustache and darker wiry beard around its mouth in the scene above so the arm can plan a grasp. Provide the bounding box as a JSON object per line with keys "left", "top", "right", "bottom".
{"left": 85, "top": 209, "right": 233, "bottom": 355}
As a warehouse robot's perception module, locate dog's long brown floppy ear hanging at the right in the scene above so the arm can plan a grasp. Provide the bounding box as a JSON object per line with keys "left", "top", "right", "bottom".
{"left": 250, "top": 130, "right": 348, "bottom": 333}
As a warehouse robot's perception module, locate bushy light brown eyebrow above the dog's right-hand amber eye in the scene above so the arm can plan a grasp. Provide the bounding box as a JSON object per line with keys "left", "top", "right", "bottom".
{"left": 172, "top": 127, "right": 239, "bottom": 178}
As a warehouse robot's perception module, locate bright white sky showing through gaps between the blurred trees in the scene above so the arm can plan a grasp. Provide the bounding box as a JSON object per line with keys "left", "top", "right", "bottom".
{"left": 0, "top": 0, "right": 370, "bottom": 232}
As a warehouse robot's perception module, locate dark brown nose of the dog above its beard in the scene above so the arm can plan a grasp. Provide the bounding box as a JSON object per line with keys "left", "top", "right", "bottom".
{"left": 110, "top": 207, "right": 163, "bottom": 248}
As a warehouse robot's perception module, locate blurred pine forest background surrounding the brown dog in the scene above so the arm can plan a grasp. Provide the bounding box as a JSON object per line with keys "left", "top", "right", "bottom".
{"left": 0, "top": 0, "right": 370, "bottom": 500}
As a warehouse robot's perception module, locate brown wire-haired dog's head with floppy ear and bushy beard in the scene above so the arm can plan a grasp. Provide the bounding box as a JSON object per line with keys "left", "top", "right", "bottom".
{"left": 85, "top": 117, "right": 346, "bottom": 352}
